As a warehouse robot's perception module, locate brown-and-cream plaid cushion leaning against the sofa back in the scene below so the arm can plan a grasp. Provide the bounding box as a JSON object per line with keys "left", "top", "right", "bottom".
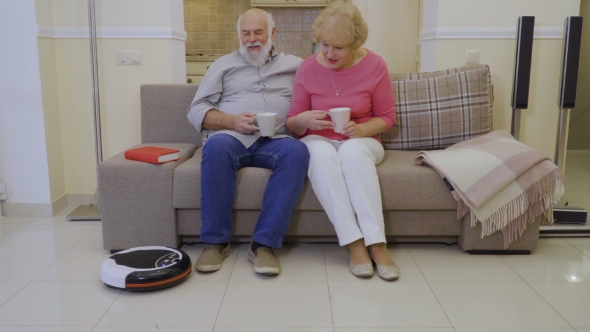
{"left": 379, "top": 65, "right": 493, "bottom": 150}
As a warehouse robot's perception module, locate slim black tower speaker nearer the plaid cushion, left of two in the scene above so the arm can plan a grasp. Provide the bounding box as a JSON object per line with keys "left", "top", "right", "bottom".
{"left": 512, "top": 16, "right": 535, "bottom": 109}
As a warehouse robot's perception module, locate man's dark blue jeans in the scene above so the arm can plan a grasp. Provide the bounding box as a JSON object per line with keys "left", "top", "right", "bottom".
{"left": 201, "top": 134, "right": 309, "bottom": 248}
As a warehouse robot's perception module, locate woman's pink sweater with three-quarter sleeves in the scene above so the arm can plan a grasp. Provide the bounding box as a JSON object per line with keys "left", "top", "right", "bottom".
{"left": 288, "top": 50, "right": 395, "bottom": 141}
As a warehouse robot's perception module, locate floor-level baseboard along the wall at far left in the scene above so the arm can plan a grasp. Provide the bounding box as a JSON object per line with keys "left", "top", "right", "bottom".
{"left": 0, "top": 194, "right": 97, "bottom": 217}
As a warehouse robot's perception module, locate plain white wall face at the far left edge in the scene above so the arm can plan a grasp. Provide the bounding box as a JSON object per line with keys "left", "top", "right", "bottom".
{"left": 0, "top": 0, "right": 50, "bottom": 208}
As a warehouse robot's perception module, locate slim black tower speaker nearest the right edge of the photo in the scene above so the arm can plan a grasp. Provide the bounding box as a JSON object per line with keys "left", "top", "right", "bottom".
{"left": 559, "top": 16, "right": 583, "bottom": 109}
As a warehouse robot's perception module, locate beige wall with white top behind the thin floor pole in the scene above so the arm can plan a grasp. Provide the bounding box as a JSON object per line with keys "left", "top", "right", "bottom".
{"left": 43, "top": 0, "right": 186, "bottom": 200}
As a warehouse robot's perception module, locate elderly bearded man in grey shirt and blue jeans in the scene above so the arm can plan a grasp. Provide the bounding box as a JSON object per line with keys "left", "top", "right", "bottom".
{"left": 188, "top": 9, "right": 309, "bottom": 275}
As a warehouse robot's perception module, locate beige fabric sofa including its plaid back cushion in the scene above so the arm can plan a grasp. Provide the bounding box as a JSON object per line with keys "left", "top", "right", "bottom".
{"left": 98, "top": 66, "right": 539, "bottom": 254}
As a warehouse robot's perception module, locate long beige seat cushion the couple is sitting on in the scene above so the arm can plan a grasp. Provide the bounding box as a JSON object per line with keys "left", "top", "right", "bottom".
{"left": 173, "top": 148, "right": 457, "bottom": 211}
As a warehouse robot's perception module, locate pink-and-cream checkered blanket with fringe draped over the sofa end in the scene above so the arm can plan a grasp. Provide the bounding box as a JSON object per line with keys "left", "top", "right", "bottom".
{"left": 416, "top": 130, "right": 566, "bottom": 247}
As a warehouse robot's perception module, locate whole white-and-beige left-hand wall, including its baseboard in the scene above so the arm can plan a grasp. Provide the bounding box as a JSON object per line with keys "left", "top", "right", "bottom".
{"left": 0, "top": 0, "right": 185, "bottom": 215}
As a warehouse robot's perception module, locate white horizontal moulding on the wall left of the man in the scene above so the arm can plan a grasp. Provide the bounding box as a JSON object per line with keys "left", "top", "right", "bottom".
{"left": 37, "top": 25, "right": 186, "bottom": 41}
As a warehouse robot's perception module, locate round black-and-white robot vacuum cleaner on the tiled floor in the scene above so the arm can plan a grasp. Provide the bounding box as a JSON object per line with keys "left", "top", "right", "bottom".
{"left": 100, "top": 246, "right": 192, "bottom": 292}
